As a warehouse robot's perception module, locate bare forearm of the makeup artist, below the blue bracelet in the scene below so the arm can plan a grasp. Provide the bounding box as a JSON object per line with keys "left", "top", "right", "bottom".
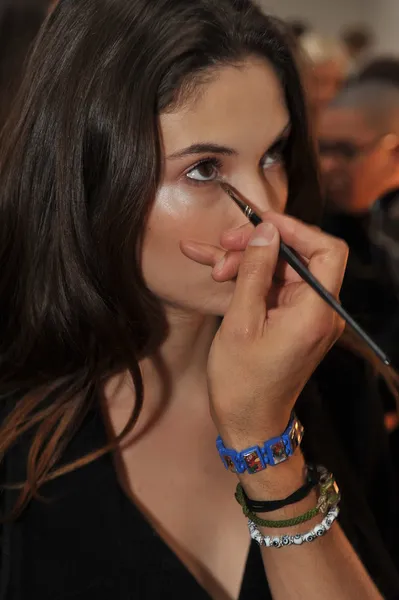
{"left": 241, "top": 454, "right": 382, "bottom": 600}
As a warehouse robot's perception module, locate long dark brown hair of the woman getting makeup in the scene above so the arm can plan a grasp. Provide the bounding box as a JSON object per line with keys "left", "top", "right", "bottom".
{"left": 0, "top": 0, "right": 321, "bottom": 512}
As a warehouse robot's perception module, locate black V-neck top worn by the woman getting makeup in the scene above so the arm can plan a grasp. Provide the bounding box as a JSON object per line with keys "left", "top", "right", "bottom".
{"left": 0, "top": 350, "right": 399, "bottom": 600}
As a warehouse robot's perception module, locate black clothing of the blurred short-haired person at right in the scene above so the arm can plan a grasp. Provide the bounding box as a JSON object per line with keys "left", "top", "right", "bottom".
{"left": 323, "top": 189, "right": 399, "bottom": 369}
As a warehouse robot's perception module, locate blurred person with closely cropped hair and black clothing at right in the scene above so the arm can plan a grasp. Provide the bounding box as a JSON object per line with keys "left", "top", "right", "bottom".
{"left": 319, "top": 81, "right": 399, "bottom": 440}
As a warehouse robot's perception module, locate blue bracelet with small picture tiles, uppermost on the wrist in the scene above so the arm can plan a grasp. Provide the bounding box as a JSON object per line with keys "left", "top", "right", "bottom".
{"left": 216, "top": 413, "right": 304, "bottom": 474}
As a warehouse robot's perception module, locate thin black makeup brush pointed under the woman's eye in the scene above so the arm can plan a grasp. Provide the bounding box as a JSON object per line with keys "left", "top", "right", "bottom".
{"left": 220, "top": 182, "right": 391, "bottom": 366}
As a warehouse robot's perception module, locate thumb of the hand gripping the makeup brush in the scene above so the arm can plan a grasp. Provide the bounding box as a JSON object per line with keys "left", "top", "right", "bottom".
{"left": 229, "top": 223, "right": 280, "bottom": 334}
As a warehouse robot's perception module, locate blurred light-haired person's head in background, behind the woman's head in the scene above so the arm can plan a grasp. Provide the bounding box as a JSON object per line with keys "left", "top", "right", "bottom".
{"left": 299, "top": 32, "right": 350, "bottom": 129}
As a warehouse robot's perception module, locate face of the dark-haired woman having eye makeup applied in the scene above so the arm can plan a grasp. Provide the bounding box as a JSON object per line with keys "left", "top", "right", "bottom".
{"left": 142, "top": 59, "right": 289, "bottom": 315}
